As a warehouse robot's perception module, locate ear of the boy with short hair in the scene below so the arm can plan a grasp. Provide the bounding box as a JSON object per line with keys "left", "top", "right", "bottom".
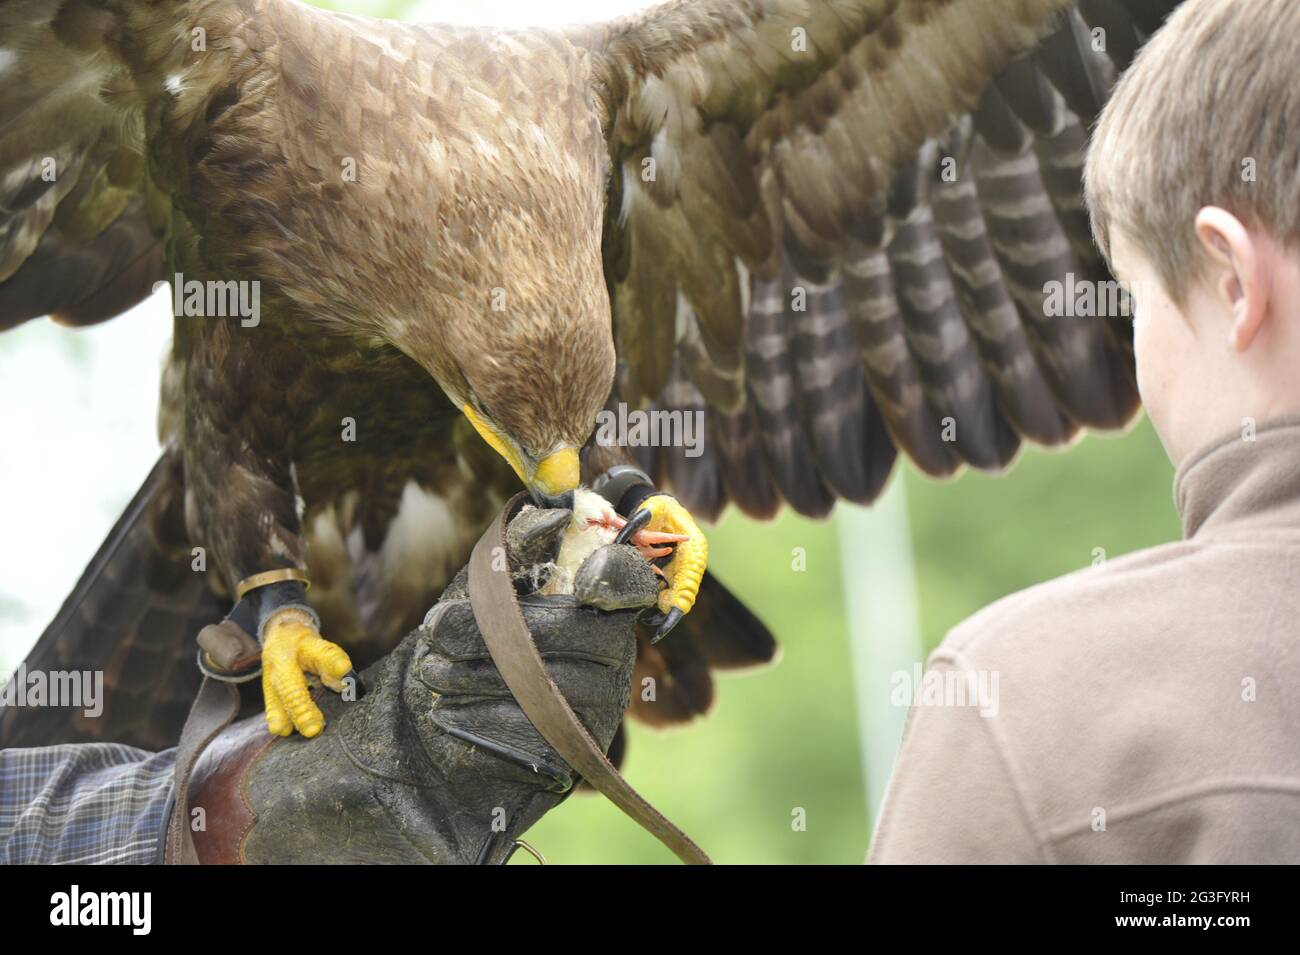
{"left": 1196, "top": 205, "right": 1269, "bottom": 351}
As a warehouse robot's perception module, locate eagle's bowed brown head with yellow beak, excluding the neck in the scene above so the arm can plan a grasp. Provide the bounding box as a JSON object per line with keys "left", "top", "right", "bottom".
{"left": 390, "top": 197, "right": 615, "bottom": 507}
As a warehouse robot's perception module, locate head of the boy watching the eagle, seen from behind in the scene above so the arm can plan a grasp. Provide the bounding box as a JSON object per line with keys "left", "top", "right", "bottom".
{"left": 1084, "top": 0, "right": 1300, "bottom": 464}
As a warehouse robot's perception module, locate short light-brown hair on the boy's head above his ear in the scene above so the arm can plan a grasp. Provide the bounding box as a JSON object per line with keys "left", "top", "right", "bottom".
{"left": 1084, "top": 0, "right": 1300, "bottom": 304}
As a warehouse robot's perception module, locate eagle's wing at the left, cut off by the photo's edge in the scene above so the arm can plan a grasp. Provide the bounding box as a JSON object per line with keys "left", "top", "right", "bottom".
{"left": 0, "top": 0, "right": 170, "bottom": 331}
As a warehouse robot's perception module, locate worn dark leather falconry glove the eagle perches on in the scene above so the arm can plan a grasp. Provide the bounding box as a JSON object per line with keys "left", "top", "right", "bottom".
{"left": 171, "top": 508, "right": 659, "bottom": 863}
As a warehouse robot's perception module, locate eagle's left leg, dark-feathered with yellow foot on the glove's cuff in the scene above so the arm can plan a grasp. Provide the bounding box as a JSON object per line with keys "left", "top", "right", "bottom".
{"left": 183, "top": 328, "right": 352, "bottom": 737}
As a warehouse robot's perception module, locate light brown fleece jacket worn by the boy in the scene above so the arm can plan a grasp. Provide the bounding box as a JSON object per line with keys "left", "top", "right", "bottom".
{"left": 868, "top": 417, "right": 1300, "bottom": 863}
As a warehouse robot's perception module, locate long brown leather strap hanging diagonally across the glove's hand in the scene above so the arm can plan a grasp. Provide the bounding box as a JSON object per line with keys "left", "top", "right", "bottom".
{"left": 469, "top": 495, "right": 710, "bottom": 865}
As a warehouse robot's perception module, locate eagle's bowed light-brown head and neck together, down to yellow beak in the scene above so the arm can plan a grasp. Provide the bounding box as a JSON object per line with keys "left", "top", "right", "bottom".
{"left": 327, "top": 34, "right": 615, "bottom": 505}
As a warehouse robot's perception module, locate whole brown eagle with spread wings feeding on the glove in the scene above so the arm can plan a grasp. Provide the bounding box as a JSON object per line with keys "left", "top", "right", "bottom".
{"left": 0, "top": 0, "right": 1177, "bottom": 747}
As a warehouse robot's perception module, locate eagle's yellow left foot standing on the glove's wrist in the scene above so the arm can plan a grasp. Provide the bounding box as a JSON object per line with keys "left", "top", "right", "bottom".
{"left": 261, "top": 607, "right": 352, "bottom": 737}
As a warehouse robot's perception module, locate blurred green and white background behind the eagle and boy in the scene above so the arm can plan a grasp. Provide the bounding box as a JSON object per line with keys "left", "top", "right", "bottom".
{"left": 0, "top": 0, "right": 1179, "bottom": 864}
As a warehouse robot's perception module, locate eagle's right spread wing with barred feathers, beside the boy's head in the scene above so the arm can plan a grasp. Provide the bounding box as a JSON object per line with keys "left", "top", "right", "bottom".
{"left": 573, "top": 0, "right": 1177, "bottom": 515}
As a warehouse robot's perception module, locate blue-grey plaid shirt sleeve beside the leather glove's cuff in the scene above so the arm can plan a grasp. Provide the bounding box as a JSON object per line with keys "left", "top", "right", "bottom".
{"left": 0, "top": 743, "right": 176, "bottom": 864}
